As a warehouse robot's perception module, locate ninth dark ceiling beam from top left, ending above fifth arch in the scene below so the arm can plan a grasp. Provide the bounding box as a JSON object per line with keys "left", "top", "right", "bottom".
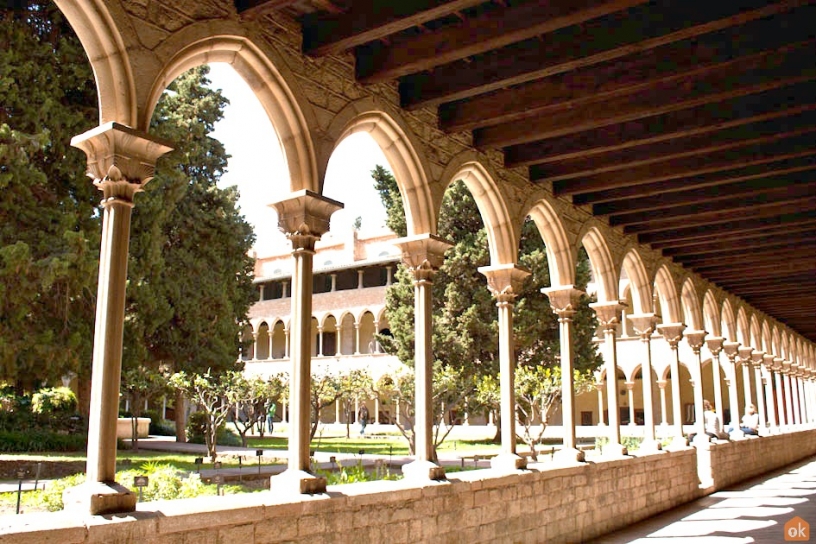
{"left": 548, "top": 147, "right": 816, "bottom": 196}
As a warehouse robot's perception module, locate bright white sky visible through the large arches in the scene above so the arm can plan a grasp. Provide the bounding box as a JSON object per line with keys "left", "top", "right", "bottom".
{"left": 209, "top": 63, "right": 390, "bottom": 256}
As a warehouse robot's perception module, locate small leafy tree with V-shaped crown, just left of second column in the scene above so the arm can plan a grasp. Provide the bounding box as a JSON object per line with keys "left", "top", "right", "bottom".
{"left": 170, "top": 370, "right": 242, "bottom": 463}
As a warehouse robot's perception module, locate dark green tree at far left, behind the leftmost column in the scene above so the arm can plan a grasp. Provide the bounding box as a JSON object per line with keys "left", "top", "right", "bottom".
{"left": 0, "top": 1, "right": 100, "bottom": 392}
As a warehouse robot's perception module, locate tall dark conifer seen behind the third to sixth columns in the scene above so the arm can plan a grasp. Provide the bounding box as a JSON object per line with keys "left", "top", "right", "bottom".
{"left": 372, "top": 168, "right": 602, "bottom": 446}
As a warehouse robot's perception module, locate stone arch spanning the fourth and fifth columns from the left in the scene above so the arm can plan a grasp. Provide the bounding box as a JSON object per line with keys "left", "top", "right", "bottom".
{"left": 528, "top": 199, "right": 577, "bottom": 287}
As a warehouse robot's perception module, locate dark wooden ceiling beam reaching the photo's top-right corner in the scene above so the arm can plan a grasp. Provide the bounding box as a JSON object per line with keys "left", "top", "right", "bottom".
{"left": 399, "top": 0, "right": 809, "bottom": 109}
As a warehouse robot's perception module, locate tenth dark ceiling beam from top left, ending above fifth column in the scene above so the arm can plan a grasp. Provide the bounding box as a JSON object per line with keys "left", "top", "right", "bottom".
{"left": 572, "top": 160, "right": 816, "bottom": 205}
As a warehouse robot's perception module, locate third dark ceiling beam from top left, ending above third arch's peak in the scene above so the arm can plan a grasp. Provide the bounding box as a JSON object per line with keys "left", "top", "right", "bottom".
{"left": 355, "top": 0, "right": 648, "bottom": 84}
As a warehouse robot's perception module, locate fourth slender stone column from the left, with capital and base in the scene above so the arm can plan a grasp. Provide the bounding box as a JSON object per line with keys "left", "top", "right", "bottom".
{"left": 479, "top": 264, "right": 532, "bottom": 471}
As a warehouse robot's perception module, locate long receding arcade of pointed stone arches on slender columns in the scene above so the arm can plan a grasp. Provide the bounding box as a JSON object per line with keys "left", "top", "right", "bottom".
{"left": 57, "top": 0, "right": 816, "bottom": 513}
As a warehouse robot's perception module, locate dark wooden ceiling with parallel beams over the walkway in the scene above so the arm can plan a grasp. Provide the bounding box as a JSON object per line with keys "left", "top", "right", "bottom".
{"left": 235, "top": 0, "right": 816, "bottom": 342}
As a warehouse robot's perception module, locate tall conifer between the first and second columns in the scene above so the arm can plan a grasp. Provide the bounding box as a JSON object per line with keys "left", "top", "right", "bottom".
{"left": 125, "top": 66, "right": 255, "bottom": 440}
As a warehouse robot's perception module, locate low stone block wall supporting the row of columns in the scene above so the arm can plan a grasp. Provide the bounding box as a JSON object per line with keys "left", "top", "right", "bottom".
{"left": 0, "top": 430, "right": 816, "bottom": 544}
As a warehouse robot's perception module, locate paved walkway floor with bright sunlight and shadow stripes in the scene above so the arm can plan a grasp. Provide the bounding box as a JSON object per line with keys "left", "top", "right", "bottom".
{"left": 593, "top": 458, "right": 816, "bottom": 544}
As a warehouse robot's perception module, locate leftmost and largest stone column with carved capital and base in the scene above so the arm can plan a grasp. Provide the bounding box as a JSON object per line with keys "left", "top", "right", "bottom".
{"left": 64, "top": 123, "right": 172, "bottom": 514}
